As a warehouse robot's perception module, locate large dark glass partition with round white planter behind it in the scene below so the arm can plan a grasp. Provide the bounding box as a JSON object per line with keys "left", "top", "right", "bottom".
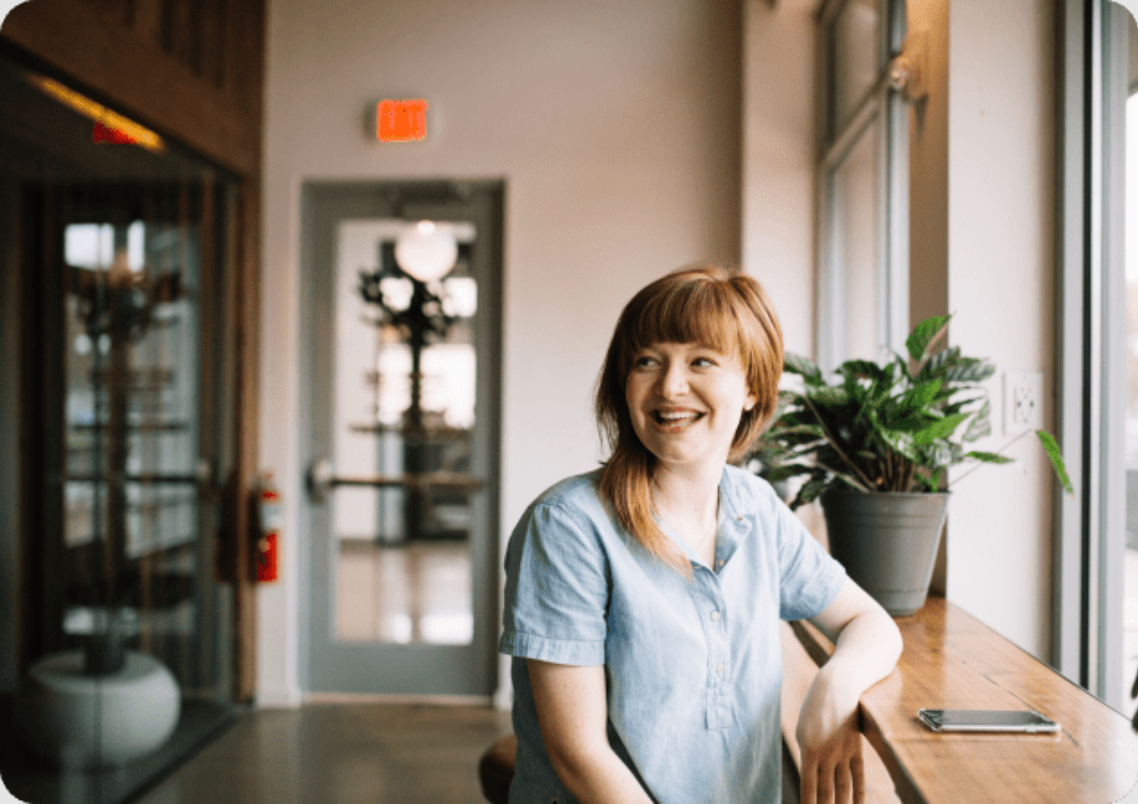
{"left": 0, "top": 52, "right": 237, "bottom": 804}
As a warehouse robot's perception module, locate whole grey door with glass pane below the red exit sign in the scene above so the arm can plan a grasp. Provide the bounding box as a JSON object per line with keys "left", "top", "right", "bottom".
{"left": 300, "top": 182, "right": 503, "bottom": 696}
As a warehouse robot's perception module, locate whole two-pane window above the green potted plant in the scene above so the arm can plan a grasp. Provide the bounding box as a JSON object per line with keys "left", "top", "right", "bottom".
{"left": 818, "top": 0, "right": 909, "bottom": 371}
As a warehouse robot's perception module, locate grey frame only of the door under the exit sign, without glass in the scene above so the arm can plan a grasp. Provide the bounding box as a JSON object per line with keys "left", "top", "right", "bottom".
{"left": 297, "top": 180, "right": 505, "bottom": 699}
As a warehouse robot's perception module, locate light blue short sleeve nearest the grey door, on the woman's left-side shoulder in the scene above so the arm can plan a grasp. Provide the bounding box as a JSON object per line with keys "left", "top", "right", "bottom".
{"left": 498, "top": 503, "right": 609, "bottom": 665}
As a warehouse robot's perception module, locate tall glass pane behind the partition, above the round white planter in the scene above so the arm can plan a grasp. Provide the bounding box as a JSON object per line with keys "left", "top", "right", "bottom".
{"left": 64, "top": 209, "right": 200, "bottom": 641}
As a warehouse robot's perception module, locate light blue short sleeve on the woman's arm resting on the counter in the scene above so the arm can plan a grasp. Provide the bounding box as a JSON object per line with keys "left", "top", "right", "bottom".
{"left": 774, "top": 499, "right": 846, "bottom": 620}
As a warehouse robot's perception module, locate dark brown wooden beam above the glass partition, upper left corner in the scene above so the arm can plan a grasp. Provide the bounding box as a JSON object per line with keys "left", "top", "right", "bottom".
{"left": 2, "top": 0, "right": 264, "bottom": 175}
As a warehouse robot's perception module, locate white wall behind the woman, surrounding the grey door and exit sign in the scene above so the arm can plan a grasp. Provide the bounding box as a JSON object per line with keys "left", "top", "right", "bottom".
{"left": 257, "top": 0, "right": 742, "bottom": 704}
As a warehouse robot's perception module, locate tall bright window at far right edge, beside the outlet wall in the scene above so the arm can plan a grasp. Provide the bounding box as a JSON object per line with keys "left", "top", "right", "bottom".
{"left": 1053, "top": 0, "right": 1138, "bottom": 714}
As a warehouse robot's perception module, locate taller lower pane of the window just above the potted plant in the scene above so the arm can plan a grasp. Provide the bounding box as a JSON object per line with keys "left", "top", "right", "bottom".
{"left": 833, "top": 118, "right": 883, "bottom": 360}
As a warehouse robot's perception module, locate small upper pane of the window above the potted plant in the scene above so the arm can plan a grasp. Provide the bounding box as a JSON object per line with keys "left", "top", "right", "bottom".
{"left": 831, "top": 0, "right": 881, "bottom": 125}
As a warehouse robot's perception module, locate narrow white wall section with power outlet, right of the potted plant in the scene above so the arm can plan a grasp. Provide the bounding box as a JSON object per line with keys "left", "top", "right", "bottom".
{"left": 948, "top": 0, "right": 1055, "bottom": 661}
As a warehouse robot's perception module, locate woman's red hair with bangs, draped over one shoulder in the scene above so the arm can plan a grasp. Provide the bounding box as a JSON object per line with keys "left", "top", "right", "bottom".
{"left": 595, "top": 264, "right": 783, "bottom": 578}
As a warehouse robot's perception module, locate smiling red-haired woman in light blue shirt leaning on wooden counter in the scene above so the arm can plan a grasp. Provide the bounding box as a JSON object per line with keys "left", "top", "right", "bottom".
{"left": 500, "top": 265, "right": 901, "bottom": 804}
